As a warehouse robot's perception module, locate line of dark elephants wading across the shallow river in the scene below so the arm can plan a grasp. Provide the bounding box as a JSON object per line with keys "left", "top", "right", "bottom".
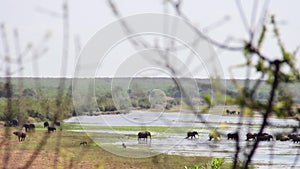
{"left": 138, "top": 131, "right": 300, "bottom": 143}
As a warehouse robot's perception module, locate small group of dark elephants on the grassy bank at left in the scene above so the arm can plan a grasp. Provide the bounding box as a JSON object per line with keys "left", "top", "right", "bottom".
{"left": 13, "top": 121, "right": 60, "bottom": 141}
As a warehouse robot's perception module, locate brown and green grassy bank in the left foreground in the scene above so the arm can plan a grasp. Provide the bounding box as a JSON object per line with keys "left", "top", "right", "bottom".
{"left": 0, "top": 124, "right": 227, "bottom": 169}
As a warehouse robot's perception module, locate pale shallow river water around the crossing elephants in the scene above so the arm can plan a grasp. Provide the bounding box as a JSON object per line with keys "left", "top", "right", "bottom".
{"left": 65, "top": 111, "right": 300, "bottom": 168}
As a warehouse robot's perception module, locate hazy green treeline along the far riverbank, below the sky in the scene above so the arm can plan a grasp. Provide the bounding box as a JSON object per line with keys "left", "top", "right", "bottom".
{"left": 0, "top": 78, "right": 300, "bottom": 121}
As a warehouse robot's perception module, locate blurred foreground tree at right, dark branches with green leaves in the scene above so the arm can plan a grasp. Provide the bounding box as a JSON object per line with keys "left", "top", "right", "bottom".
{"left": 109, "top": 0, "right": 300, "bottom": 169}
